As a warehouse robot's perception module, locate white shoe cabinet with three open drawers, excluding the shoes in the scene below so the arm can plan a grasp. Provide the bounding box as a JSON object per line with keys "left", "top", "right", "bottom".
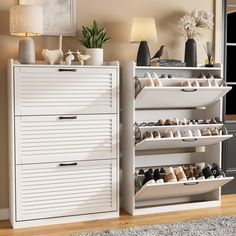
{"left": 122, "top": 62, "right": 232, "bottom": 215}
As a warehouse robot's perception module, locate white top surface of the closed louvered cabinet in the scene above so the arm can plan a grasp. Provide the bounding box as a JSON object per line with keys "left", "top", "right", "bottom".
{"left": 9, "top": 59, "right": 119, "bottom": 68}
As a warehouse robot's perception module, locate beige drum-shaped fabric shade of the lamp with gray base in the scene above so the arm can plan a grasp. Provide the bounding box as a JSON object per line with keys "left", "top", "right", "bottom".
{"left": 10, "top": 5, "right": 43, "bottom": 36}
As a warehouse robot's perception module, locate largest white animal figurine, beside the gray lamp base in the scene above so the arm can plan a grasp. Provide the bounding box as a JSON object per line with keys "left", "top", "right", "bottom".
{"left": 42, "top": 35, "right": 63, "bottom": 65}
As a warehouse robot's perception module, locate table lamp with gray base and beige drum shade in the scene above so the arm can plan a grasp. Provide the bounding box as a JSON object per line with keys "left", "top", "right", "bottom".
{"left": 10, "top": 5, "right": 43, "bottom": 64}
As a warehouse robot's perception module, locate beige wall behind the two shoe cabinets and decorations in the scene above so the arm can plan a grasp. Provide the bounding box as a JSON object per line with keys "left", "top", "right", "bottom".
{"left": 0, "top": 0, "right": 214, "bottom": 209}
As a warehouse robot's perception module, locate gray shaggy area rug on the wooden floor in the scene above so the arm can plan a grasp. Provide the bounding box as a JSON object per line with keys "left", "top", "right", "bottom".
{"left": 74, "top": 216, "right": 236, "bottom": 236}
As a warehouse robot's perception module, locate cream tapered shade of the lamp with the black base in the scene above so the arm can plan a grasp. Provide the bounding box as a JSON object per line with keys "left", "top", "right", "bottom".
{"left": 130, "top": 17, "right": 157, "bottom": 42}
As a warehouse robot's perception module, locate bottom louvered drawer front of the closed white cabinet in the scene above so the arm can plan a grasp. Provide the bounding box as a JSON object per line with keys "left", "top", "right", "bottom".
{"left": 16, "top": 160, "right": 117, "bottom": 221}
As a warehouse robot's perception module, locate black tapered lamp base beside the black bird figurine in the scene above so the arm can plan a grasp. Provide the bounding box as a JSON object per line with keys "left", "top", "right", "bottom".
{"left": 136, "top": 41, "right": 151, "bottom": 66}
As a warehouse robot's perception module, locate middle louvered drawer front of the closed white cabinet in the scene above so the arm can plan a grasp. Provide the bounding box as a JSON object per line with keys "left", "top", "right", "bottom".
{"left": 15, "top": 114, "right": 118, "bottom": 164}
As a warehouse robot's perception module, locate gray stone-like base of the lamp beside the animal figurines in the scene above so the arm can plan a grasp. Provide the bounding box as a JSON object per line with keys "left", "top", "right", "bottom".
{"left": 18, "top": 37, "right": 35, "bottom": 64}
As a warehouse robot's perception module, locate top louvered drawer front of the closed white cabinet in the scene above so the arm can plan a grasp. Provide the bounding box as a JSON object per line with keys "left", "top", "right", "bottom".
{"left": 15, "top": 67, "right": 118, "bottom": 115}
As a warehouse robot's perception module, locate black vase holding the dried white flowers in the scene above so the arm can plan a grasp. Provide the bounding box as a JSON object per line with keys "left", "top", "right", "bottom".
{"left": 184, "top": 39, "right": 197, "bottom": 67}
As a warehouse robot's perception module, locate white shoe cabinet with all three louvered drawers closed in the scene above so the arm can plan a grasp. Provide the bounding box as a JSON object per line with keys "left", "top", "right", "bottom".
{"left": 8, "top": 60, "right": 119, "bottom": 228}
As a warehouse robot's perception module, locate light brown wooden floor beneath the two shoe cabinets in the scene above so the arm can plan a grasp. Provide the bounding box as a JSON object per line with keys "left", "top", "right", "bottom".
{"left": 0, "top": 194, "right": 236, "bottom": 236}
